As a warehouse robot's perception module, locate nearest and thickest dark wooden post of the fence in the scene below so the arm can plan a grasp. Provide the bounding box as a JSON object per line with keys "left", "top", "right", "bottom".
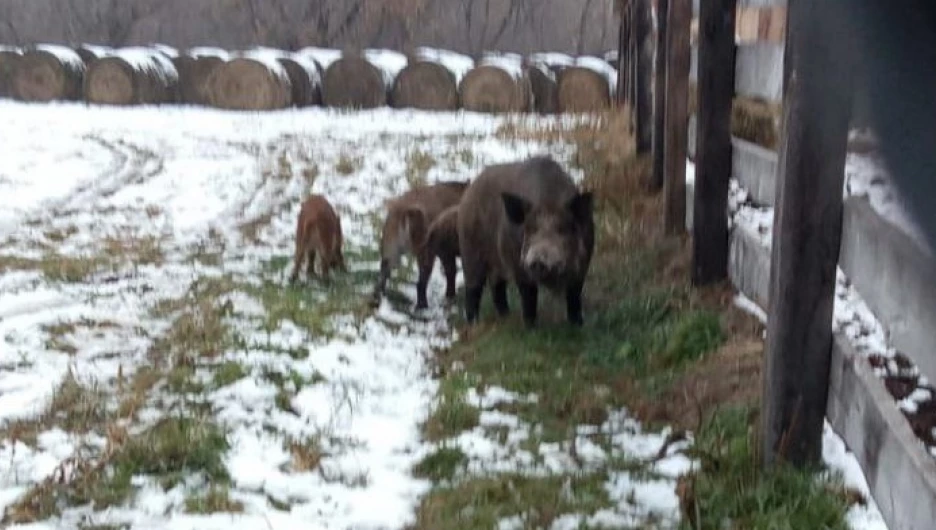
{"left": 762, "top": 0, "right": 854, "bottom": 467}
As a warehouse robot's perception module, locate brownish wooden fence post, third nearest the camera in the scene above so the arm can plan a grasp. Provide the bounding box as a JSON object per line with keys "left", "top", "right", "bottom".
{"left": 663, "top": 0, "right": 692, "bottom": 235}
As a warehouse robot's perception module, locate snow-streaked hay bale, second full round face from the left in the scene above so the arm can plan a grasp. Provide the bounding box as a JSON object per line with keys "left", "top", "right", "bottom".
{"left": 84, "top": 47, "right": 179, "bottom": 105}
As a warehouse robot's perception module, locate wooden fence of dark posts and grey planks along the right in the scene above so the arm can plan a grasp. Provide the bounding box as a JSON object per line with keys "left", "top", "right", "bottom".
{"left": 654, "top": 0, "right": 936, "bottom": 530}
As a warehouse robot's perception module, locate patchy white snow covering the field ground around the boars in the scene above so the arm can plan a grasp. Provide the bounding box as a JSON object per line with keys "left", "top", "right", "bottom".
{"left": 0, "top": 101, "right": 691, "bottom": 529}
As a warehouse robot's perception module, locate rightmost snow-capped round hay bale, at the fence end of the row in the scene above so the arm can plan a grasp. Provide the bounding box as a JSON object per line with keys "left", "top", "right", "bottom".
{"left": 559, "top": 57, "right": 617, "bottom": 112}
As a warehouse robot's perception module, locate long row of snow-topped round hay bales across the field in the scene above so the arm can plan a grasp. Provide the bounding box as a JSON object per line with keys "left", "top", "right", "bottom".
{"left": 0, "top": 44, "right": 617, "bottom": 114}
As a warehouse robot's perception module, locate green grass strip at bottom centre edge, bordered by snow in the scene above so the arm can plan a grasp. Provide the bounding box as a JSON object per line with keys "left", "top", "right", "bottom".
{"left": 412, "top": 473, "right": 611, "bottom": 530}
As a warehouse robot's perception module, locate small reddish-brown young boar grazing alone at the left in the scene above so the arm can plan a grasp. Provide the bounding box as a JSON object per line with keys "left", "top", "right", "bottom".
{"left": 289, "top": 194, "right": 348, "bottom": 284}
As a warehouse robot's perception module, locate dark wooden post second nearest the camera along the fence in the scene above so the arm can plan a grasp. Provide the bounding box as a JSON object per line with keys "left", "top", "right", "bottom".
{"left": 692, "top": 0, "right": 737, "bottom": 285}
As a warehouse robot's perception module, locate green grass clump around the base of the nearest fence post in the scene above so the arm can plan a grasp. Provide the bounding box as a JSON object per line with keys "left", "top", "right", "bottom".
{"left": 683, "top": 407, "right": 848, "bottom": 530}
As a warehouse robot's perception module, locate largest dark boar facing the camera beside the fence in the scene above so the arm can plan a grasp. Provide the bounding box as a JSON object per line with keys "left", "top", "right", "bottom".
{"left": 458, "top": 156, "right": 595, "bottom": 327}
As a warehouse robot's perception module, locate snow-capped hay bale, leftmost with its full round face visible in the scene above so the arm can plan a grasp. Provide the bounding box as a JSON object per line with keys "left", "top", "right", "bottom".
{"left": 13, "top": 44, "right": 85, "bottom": 102}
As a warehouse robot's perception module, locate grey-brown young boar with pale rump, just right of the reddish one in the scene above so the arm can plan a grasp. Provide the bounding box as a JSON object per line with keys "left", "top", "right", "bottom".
{"left": 373, "top": 181, "right": 468, "bottom": 309}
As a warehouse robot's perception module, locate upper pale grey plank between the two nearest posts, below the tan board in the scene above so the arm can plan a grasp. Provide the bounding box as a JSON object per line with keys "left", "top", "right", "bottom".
{"left": 735, "top": 42, "right": 783, "bottom": 101}
